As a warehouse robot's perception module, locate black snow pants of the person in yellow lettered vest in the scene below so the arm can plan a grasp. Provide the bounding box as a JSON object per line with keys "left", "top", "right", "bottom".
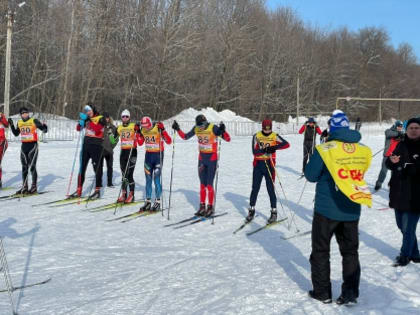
{"left": 309, "top": 212, "right": 360, "bottom": 298}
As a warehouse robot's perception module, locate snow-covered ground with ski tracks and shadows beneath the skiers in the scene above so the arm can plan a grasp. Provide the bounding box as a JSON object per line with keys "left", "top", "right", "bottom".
{"left": 0, "top": 135, "right": 420, "bottom": 315}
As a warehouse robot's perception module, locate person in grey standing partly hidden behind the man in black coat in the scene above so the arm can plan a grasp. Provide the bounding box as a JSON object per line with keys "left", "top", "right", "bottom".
{"left": 375, "top": 120, "right": 404, "bottom": 191}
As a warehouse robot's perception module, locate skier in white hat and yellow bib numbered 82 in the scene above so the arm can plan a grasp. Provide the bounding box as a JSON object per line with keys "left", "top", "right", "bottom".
{"left": 109, "top": 109, "right": 140, "bottom": 203}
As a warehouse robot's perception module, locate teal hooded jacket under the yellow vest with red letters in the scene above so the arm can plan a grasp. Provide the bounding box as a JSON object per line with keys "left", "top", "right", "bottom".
{"left": 305, "top": 129, "right": 362, "bottom": 221}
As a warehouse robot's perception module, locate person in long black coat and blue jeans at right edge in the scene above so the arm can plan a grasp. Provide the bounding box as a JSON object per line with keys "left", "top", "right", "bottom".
{"left": 385, "top": 118, "right": 420, "bottom": 266}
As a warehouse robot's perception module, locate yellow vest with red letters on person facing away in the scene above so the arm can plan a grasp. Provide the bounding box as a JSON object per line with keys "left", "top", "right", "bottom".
{"left": 316, "top": 141, "right": 372, "bottom": 208}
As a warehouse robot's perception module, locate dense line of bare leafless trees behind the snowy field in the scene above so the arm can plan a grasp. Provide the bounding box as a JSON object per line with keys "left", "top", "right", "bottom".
{"left": 0, "top": 0, "right": 420, "bottom": 121}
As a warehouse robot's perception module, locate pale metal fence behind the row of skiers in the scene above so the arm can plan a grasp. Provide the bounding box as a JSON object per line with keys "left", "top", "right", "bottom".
{"left": 7, "top": 118, "right": 392, "bottom": 141}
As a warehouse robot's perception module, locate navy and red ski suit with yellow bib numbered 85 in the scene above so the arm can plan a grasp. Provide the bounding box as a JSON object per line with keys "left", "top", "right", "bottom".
{"left": 178, "top": 124, "right": 230, "bottom": 205}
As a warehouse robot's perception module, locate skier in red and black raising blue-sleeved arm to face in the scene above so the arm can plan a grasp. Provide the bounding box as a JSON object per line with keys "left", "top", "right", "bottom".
{"left": 71, "top": 104, "right": 106, "bottom": 199}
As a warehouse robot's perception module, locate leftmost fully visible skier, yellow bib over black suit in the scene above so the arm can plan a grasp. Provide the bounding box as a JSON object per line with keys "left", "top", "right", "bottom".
{"left": 9, "top": 107, "right": 48, "bottom": 194}
